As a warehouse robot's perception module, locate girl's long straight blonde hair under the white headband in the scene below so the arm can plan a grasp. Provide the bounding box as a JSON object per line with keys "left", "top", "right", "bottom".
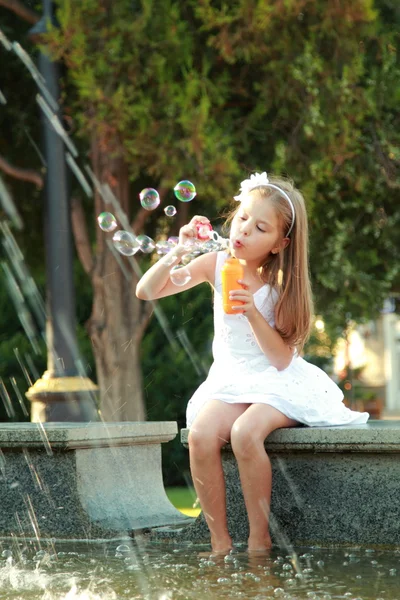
{"left": 226, "top": 175, "right": 313, "bottom": 352}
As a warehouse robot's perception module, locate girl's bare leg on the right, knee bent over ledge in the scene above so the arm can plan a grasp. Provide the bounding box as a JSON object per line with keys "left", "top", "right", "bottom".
{"left": 231, "top": 404, "right": 298, "bottom": 552}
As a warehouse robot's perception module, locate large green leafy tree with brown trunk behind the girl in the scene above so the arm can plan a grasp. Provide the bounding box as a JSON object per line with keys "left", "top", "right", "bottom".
{"left": 0, "top": 0, "right": 400, "bottom": 426}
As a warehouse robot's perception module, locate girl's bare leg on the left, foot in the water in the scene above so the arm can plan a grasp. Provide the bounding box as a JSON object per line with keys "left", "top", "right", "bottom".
{"left": 188, "top": 400, "right": 249, "bottom": 552}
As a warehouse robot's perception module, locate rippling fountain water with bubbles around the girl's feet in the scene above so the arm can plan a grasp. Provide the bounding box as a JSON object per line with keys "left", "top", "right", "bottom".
{"left": 0, "top": 542, "right": 400, "bottom": 600}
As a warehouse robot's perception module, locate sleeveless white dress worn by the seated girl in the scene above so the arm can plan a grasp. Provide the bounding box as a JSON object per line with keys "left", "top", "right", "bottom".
{"left": 186, "top": 252, "right": 369, "bottom": 427}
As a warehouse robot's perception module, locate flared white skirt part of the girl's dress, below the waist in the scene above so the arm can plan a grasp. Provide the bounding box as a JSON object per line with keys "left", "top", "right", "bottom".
{"left": 186, "top": 355, "right": 369, "bottom": 427}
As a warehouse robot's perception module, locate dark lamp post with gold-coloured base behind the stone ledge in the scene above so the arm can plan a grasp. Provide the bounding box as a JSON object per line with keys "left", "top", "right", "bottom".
{"left": 26, "top": 0, "right": 99, "bottom": 422}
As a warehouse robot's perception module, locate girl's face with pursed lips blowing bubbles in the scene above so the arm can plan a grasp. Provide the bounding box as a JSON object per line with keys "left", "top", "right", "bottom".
{"left": 229, "top": 193, "right": 289, "bottom": 266}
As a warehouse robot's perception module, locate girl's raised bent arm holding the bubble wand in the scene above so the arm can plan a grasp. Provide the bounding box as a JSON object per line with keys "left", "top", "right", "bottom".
{"left": 136, "top": 216, "right": 216, "bottom": 300}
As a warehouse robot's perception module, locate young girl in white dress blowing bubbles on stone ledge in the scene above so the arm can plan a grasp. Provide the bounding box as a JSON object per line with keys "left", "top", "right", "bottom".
{"left": 136, "top": 173, "right": 369, "bottom": 553}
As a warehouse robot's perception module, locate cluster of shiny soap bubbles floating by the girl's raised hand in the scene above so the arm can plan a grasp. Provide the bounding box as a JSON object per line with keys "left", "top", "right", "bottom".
{"left": 97, "top": 180, "right": 227, "bottom": 286}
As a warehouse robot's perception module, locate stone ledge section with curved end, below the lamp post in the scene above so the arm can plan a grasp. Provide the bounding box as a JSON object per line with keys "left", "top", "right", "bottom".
{"left": 0, "top": 422, "right": 186, "bottom": 540}
